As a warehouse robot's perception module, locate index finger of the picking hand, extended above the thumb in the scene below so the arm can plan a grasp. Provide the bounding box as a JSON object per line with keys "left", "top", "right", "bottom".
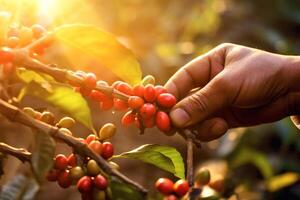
{"left": 165, "top": 45, "right": 229, "bottom": 99}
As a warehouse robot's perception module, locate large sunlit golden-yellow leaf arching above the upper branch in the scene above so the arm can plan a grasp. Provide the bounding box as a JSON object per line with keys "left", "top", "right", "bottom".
{"left": 54, "top": 24, "right": 142, "bottom": 84}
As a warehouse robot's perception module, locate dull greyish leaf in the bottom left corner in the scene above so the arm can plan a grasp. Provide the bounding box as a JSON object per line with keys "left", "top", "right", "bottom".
{"left": 0, "top": 175, "right": 39, "bottom": 200}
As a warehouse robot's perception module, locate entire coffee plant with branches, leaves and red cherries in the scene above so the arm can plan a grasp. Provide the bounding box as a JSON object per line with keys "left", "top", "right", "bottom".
{"left": 0, "top": 11, "right": 224, "bottom": 200}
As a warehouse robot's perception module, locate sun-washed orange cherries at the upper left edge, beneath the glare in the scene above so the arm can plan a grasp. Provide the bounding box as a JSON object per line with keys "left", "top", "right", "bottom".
{"left": 0, "top": 24, "right": 53, "bottom": 75}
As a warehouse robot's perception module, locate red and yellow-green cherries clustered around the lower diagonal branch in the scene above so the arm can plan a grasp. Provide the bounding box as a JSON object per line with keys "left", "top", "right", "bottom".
{"left": 47, "top": 123, "right": 119, "bottom": 200}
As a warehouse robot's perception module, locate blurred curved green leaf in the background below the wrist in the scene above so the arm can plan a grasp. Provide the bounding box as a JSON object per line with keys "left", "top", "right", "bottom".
{"left": 230, "top": 147, "right": 273, "bottom": 179}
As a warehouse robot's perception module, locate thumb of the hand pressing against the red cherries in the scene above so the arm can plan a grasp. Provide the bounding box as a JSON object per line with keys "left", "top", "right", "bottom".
{"left": 170, "top": 77, "right": 228, "bottom": 127}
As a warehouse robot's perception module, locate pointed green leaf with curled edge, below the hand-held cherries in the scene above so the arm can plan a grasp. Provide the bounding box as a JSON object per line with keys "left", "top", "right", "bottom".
{"left": 114, "top": 144, "right": 185, "bottom": 179}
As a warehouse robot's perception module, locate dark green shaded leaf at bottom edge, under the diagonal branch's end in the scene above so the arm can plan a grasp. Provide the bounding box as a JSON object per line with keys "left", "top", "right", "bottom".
{"left": 109, "top": 177, "right": 145, "bottom": 200}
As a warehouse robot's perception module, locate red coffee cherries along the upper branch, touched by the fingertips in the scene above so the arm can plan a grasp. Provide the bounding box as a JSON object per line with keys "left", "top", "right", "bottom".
{"left": 71, "top": 71, "right": 176, "bottom": 132}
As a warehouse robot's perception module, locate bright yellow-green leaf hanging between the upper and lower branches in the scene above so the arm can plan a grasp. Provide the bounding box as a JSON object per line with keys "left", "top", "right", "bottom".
{"left": 19, "top": 83, "right": 94, "bottom": 131}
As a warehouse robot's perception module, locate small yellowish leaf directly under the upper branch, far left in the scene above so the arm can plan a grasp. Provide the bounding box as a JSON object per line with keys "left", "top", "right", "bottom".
{"left": 17, "top": 68, "right": 54, "bottom": 92}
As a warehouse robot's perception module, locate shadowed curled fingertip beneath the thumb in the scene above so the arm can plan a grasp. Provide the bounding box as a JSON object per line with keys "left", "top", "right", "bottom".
{"left": 196, "top": 118, "right": 228, "bottom": 142}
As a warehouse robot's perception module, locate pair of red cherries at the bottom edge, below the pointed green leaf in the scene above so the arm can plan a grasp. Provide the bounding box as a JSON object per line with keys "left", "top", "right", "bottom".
{"left": 155, "top": 178, "right": 190, "bottom": 200}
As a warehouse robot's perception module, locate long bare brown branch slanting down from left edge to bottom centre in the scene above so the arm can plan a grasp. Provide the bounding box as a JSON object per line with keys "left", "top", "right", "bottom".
{"left": 0, "top": 99, "right": 147, "bottom": 194}
